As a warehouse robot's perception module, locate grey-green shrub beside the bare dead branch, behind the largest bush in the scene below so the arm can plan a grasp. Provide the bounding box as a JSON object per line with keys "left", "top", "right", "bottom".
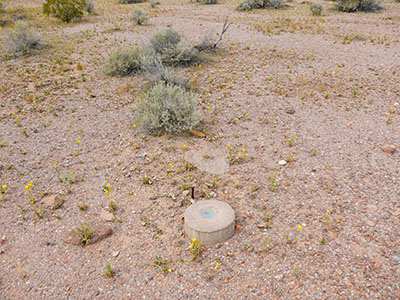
{"left": 146, "top": 28, "right": 200, "bottom": 65}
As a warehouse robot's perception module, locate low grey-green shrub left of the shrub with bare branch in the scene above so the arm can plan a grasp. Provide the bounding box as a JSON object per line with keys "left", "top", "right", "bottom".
{"left": 104, "top": 48, "right": 140, "bottom": 76}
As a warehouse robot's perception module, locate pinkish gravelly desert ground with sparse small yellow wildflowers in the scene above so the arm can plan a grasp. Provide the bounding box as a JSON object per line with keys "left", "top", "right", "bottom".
{"left": 0, "top": 0, "right": 400, "bottom": 300}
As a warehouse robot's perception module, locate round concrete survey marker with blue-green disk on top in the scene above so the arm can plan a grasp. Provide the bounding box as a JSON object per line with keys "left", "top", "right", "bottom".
{"left": 185, "top": 200, "right": 235, "bottom": 245}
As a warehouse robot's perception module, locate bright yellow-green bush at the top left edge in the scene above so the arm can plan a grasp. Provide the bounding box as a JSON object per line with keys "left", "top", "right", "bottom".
{"left": 43, "top": 0, "right": 86, "bottom": 23}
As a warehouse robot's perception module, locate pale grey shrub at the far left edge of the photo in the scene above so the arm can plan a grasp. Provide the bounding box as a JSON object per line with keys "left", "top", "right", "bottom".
{"left": 3, "top": 21, "right": 43, "bottom": 54}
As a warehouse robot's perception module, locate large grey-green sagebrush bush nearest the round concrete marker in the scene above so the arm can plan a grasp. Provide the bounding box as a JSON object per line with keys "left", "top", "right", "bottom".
{"left": 134, "top": 83, "right": 200, "bottom": 134}
